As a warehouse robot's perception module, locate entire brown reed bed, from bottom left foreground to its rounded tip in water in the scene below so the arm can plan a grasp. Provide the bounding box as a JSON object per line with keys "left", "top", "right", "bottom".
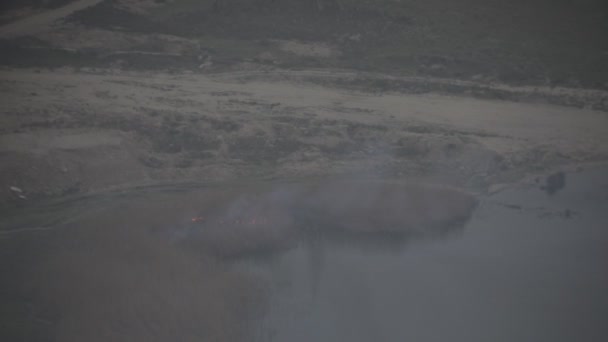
{"left": 15, "top": 181, "right": 476, "bottom": 342}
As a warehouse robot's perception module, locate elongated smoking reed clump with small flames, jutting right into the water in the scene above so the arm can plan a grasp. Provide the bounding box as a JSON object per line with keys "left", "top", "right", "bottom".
{"left": 173, "top": 181, "right": 477, "bottom": 254}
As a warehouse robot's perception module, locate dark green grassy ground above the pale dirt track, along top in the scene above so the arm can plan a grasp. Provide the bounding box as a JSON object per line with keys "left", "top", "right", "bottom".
{"left": 72, "top": 0, "right": 608, "bottom": 88}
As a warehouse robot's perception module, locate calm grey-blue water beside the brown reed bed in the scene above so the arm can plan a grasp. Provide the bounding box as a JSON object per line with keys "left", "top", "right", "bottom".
{"left": 250, "top": 168, "right": 608, "bottom": 342}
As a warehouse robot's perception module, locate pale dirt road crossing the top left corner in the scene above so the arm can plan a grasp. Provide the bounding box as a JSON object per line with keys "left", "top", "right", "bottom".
{"left": 0, "top": 0, "right": 103, "bottom": 39}
